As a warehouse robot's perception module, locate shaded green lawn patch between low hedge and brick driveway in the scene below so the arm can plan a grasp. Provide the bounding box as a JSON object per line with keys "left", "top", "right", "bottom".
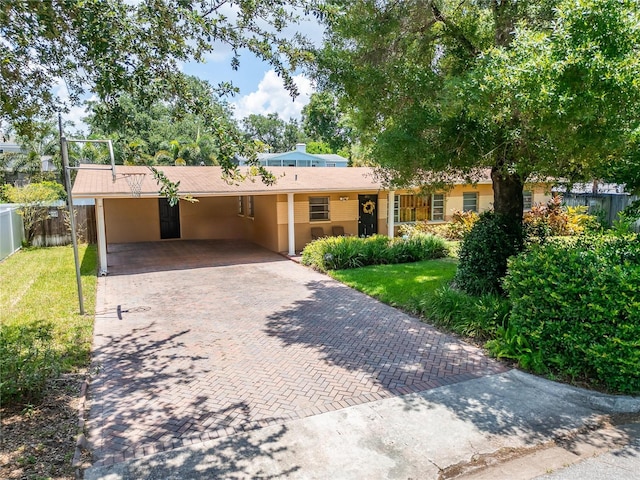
{"left": 329, "top": 258, "right": 457, "bottom": 312}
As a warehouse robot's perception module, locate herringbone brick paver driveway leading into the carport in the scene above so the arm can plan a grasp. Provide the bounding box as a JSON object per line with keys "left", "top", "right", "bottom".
{"left": 88, "top": 241, "right": 504, "bottom": 465}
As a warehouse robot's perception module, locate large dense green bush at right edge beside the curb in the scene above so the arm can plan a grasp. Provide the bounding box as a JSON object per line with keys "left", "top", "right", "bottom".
{"left": 500, "top": 236, "right": 640, "bottom": 393}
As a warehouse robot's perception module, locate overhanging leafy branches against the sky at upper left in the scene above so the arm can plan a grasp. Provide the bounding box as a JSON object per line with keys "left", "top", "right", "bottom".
{"left": 0, "top": 0, "right": 316, "bottom": 139}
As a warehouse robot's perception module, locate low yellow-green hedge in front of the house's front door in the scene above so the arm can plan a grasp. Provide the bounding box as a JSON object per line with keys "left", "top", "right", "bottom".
{"left": 301, "top": 234, "right": 448, "bottom": 272}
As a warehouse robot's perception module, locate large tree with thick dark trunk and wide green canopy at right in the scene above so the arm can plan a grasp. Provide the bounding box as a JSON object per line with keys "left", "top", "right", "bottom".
{"left": 315, "top": 0, "right": 640, "bottom": 220}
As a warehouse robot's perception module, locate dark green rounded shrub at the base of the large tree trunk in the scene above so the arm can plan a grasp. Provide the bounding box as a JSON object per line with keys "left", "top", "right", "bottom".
{"left": 455, "top": 212, "right": 523, "bottom": 295}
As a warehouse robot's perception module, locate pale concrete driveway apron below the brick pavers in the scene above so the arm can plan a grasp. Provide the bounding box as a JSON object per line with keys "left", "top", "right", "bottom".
{"left": 84, "top": 370, "right": 640, "bottom": 480}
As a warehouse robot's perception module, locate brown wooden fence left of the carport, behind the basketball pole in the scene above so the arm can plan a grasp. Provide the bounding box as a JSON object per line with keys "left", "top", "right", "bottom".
{"left": 33, "top": 205, "right": 98, "bottom": 247}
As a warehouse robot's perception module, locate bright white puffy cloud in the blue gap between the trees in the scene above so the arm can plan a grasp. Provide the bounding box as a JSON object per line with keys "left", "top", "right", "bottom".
{"left": 233, "top": 70, "right": 314, "bottom": 120}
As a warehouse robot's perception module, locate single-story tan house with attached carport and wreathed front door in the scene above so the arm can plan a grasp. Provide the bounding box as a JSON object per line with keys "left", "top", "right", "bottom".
{"left": 73, "top": 165, "right": 549, "bottom": 272}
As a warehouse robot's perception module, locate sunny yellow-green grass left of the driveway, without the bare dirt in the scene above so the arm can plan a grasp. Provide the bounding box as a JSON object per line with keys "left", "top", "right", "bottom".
{"left": 0, "top": 245, "right": 97, "bottom": 403}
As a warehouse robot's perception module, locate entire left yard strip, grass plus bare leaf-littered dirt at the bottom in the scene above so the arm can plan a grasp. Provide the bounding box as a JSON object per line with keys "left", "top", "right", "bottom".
{"left": 0, "top": 246, "right": 96, "bottom": 480}
